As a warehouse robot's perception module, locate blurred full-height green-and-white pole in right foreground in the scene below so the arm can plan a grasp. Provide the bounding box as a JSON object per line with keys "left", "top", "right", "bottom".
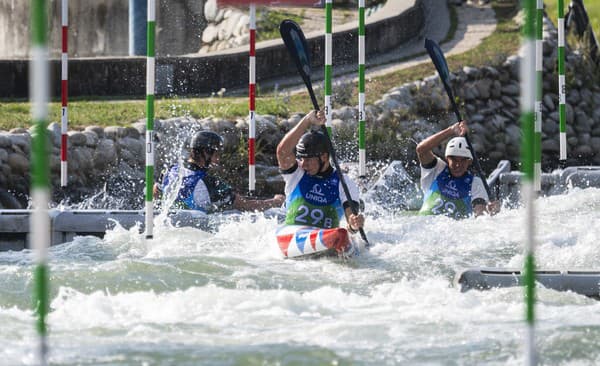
{"left": 521, "top": 0, "right": 537, "bottom": 365}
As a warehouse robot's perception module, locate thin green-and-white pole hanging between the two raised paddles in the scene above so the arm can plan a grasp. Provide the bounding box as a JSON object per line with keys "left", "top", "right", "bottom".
{"left": 358, "top": 0, "right": 367, "bottom": 177}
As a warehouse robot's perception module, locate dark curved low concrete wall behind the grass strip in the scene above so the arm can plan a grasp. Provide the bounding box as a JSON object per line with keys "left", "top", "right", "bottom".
{"left": 0, "top": 0, "right": 425, "bottom": 98}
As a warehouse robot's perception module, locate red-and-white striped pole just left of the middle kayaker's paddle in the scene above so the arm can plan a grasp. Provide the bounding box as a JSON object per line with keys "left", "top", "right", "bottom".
{"left": 248, "top": 4, "right": 256, "bottom": 196}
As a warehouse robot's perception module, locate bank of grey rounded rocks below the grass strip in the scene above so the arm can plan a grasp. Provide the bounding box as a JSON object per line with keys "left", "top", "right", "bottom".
{"left": 0, "top": 11, "right": 600, "bottom": 208}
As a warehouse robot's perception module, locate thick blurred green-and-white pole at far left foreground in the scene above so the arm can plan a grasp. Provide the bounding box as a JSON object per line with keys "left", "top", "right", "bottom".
{"left": 29, "top": 0, "right": 50, "bottom": 365}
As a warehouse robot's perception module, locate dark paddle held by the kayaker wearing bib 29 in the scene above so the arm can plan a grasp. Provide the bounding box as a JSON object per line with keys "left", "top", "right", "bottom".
{"left": 279, "top": 19, "right": 370, "bottom": 248}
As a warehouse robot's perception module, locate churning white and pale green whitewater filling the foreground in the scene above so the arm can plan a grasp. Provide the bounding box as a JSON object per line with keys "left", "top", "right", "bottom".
{"left": 0, "top": 189, "right": 600, "bottom": 365}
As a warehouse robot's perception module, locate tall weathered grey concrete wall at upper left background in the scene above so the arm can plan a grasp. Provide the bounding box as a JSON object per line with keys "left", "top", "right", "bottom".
{"left": 0, "top": 0, "right": 206, "bottom": 60}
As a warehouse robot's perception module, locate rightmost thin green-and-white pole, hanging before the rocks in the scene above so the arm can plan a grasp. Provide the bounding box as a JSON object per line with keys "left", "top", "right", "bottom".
{"left": 558, "top": 0, "right": 567, "bottom": 163}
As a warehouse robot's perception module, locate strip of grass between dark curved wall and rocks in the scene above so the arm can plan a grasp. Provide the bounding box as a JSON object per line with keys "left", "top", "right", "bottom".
{"left": 0, "top": 0, "right": 520, "bottom": 130}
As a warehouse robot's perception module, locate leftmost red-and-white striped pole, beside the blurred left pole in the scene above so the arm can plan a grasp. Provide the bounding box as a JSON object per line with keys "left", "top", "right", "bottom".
{"left": 60, "top": 0, "right": 69, "bottom": 187}
